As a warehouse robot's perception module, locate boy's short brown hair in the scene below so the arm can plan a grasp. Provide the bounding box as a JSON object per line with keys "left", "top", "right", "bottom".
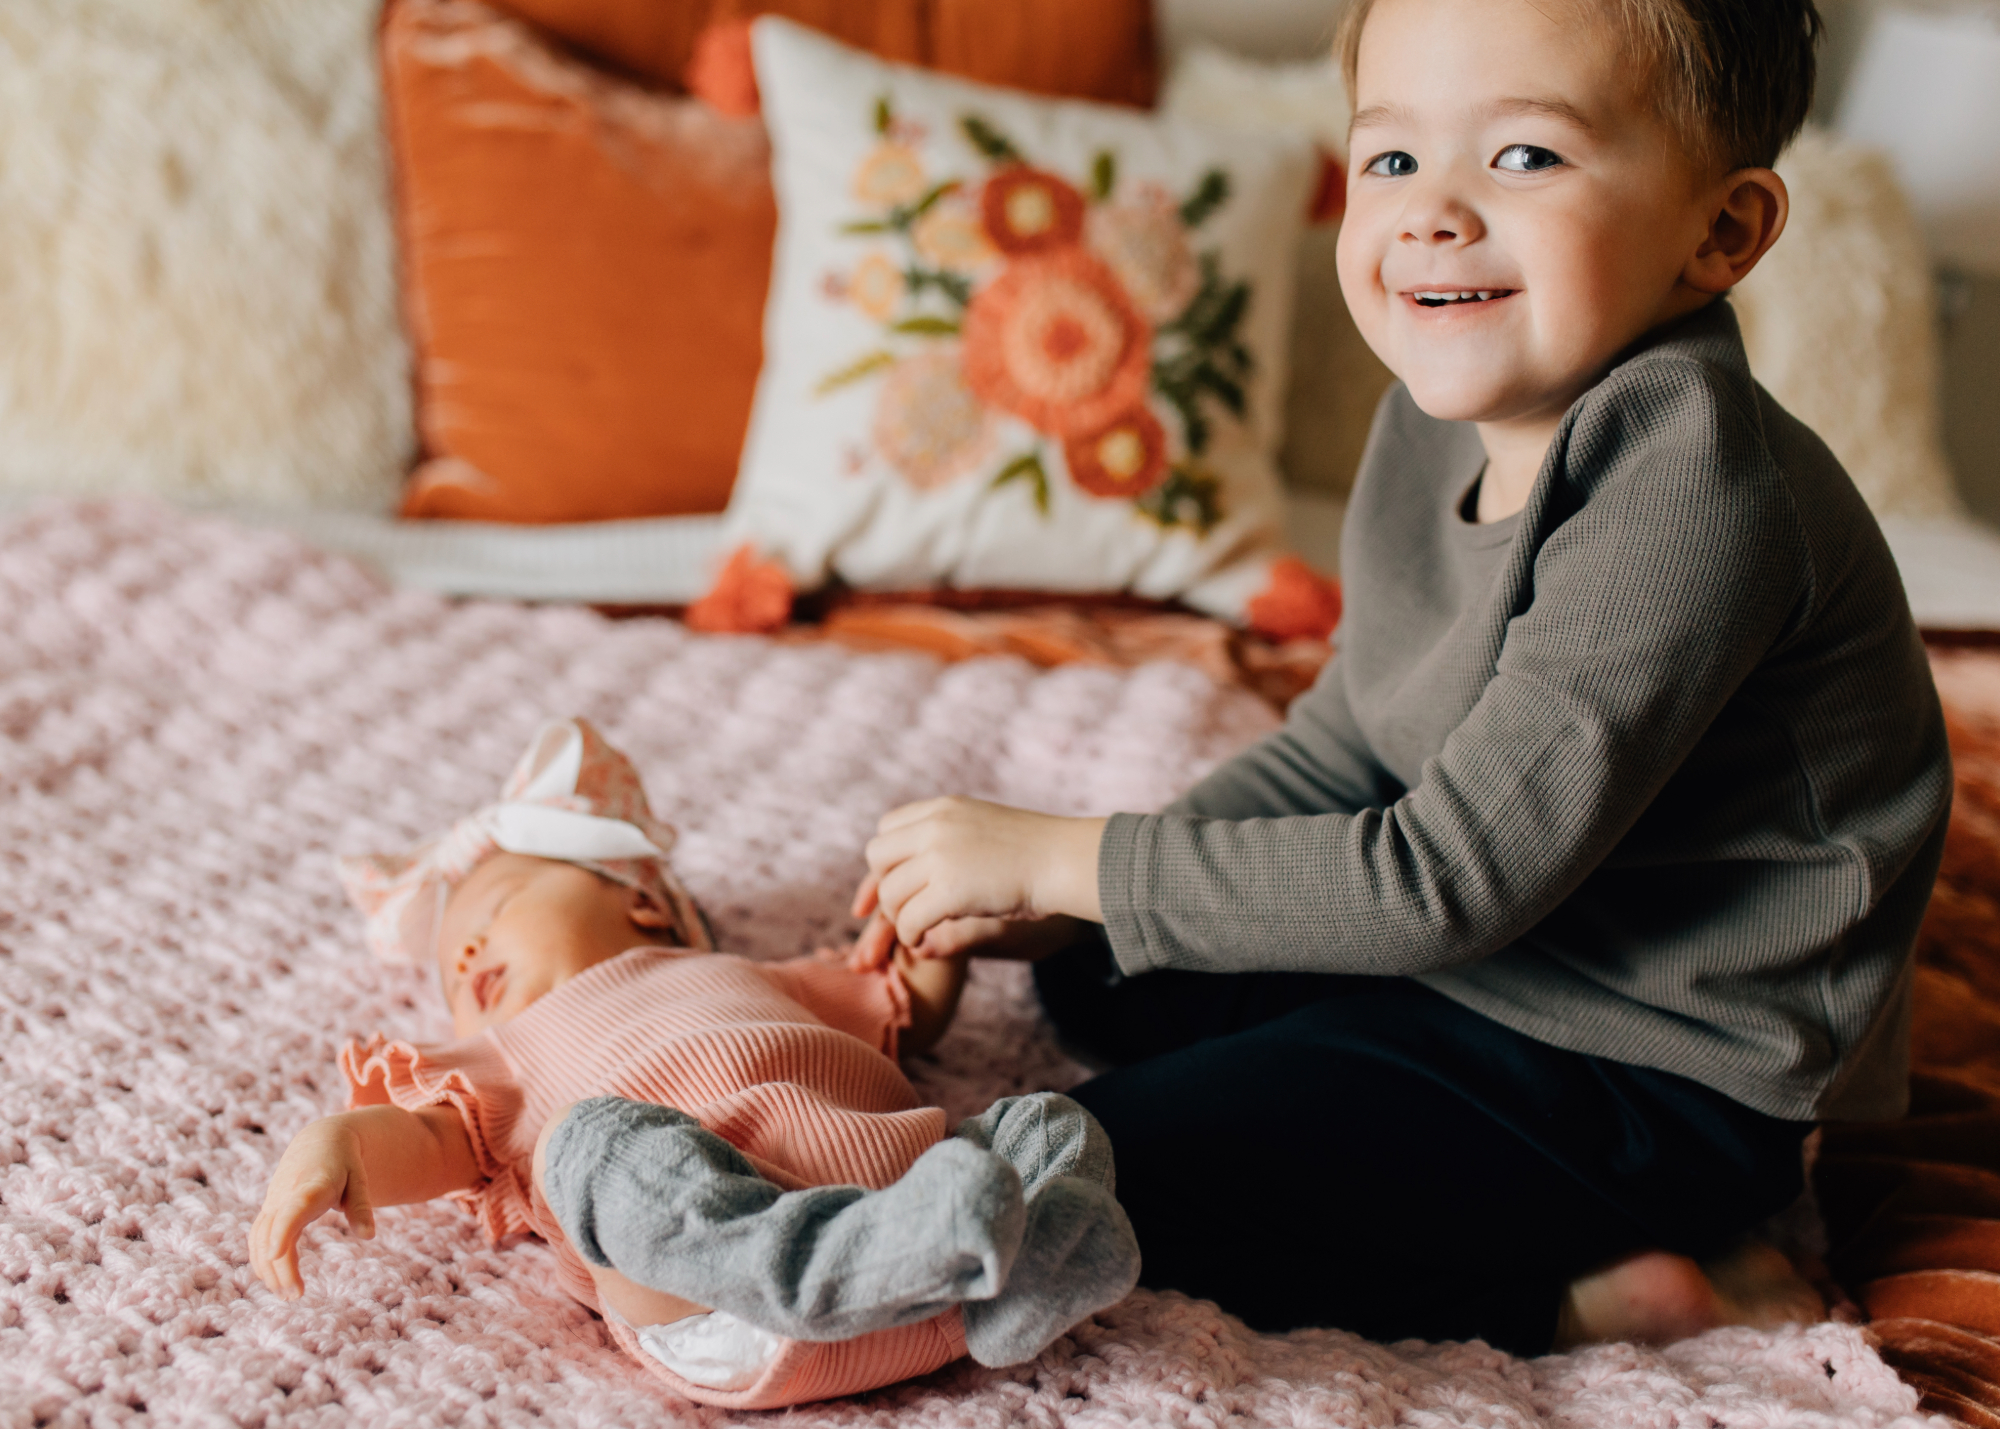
{"left": 1334, "top": 0, "right": 1824, "bottom": 172}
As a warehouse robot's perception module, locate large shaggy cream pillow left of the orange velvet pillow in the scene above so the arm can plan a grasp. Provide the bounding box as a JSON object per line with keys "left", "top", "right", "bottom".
{"left": 0, "top": 0, "right": 414, "bottom": 508}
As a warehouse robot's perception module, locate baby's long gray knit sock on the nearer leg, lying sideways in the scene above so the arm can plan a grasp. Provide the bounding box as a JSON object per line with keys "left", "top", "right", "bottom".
{"left": 544, "top": 1097, "right": 1024, "bottom": 1341}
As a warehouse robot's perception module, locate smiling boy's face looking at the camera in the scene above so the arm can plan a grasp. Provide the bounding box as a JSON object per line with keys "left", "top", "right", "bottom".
{"left": 1340, "top": 0, "right": 1712, "bottom": 422}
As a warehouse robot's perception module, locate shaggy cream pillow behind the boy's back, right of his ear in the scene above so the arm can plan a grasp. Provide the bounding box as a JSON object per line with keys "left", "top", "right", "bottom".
{"left": 1732, "top": 130, "right": 1960, "bottom": 516}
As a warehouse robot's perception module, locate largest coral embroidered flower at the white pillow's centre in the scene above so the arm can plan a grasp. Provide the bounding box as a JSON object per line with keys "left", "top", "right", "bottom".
{"left": 962, "top": 248, "right": 1152, "bottom": 436}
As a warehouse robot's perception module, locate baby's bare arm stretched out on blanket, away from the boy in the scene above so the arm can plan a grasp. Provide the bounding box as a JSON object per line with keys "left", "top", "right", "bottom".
{"left": 250, "top": 1107, "right": 484, "bottom": 1299}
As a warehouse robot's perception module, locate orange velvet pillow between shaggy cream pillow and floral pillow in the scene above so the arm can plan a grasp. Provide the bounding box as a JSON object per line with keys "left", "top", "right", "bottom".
{"left": 382, "top": 0, "right": 776, "bottom": 522}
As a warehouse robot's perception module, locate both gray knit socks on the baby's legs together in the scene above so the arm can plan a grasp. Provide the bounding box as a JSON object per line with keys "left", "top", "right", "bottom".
{"left": 542, "top": 1093, "right": 1138, "bottom": 1365}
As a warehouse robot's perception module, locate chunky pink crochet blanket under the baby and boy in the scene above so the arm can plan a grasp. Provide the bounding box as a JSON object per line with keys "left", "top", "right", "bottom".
{"left": 0, "top": 504, "right": 1922, "bottom": 1429}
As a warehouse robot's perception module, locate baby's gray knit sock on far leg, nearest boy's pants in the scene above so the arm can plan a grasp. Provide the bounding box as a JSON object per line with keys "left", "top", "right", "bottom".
{"left": 956, "top": 1093, "right": 1138, "bottom": 1367}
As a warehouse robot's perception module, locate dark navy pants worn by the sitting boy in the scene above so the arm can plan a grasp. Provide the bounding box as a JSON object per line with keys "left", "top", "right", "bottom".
{"left": 1034, "top": 937, "right": 1812, "bottom": 1355}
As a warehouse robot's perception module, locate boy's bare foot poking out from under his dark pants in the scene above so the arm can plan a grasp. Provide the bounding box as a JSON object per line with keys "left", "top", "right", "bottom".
{"left": 1552, "top": 1241, "right": 1826, "bottom": 1351}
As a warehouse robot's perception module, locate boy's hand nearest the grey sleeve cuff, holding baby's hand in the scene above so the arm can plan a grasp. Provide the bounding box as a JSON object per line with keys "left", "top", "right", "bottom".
{"left": 856, "top": 797, "right": 1104, "bottom": 949}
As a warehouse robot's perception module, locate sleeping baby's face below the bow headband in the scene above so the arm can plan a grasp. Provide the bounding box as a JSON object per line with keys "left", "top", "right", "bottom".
{"left": 438, "top": 853, "right": 670, "bottom": 1037}
